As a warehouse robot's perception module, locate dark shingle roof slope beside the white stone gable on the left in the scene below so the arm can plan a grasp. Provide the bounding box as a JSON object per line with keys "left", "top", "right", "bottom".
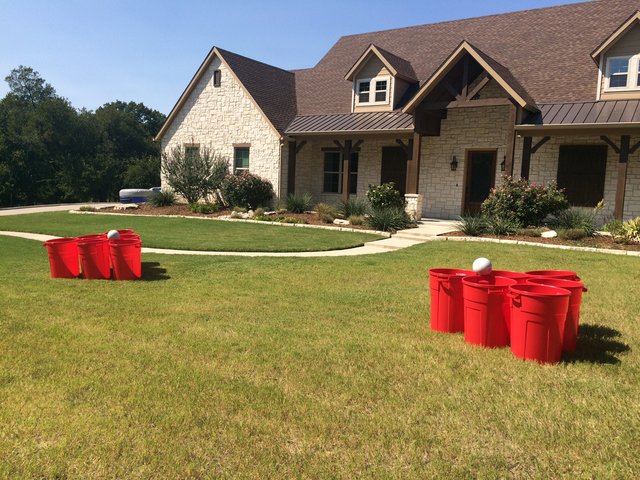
{"left": 218, "top": 48, "right": 296, "bottom": 133}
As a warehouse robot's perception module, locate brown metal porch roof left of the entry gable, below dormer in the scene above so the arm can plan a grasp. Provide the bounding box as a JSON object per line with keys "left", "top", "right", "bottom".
{"left": 285, "top": 110, "right": 413, "bottom": 135}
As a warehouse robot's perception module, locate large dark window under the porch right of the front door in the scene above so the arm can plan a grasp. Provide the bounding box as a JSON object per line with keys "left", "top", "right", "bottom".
{"left": 558, "top": 145, "right": 607, "bottom": 207}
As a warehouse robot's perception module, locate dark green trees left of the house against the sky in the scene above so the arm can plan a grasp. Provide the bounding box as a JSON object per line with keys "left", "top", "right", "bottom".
{"left": 0, "top": 66, "right": 165, "bottom": 207}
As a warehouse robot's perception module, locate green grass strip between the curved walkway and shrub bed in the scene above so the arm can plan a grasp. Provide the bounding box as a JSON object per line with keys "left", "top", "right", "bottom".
{"left": 0, "top": 212, "right": 382, "bottom": 252}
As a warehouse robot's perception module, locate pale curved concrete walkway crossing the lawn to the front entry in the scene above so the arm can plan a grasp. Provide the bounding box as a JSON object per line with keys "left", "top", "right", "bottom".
{"left": 0, "top": 220, "right": 455, "bottom": 258}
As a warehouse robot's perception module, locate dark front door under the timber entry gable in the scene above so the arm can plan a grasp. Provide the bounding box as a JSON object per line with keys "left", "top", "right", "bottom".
{"left": 462, "top": 150, "right": 496, "bottom": 214}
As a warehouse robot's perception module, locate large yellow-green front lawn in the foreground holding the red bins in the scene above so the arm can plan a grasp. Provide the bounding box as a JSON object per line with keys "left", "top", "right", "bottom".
{"left": 0, "top": 237, "right": 640, "bottom": 479}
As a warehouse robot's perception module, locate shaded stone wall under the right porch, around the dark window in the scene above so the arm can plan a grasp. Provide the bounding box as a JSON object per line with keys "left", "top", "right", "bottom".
{"left": 513, "top": 135, "right": 640, "bottom": 219}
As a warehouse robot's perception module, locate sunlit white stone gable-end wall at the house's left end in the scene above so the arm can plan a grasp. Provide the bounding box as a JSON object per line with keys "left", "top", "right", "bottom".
{"left": 162, "top": 58, "right": 286, "bottom": 195}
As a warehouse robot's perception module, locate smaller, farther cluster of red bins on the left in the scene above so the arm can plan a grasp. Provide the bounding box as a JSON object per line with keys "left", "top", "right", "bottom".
{"left": 44, "top": 229, "right": 142, "bottom": 280}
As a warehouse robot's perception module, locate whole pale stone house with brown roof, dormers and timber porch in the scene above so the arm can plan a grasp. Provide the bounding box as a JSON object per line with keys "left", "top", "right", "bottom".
{"left": 156, "top": 0, "right": 640, "bottom": 219}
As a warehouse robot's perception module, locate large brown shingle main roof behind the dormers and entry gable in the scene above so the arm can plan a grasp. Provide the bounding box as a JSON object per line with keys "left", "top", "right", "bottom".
{"left": 295, "top": 0, "right": 640, "bottom": 115}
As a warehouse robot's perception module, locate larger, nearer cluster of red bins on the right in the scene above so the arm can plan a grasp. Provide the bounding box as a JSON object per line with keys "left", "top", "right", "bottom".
{"left": 429, "top": 268, "right": 587, "bottom": 363}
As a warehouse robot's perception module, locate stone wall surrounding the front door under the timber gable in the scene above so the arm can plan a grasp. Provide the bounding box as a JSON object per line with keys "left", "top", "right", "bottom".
{"left": 419, "top": 106, "right": 508, "bottom": 218}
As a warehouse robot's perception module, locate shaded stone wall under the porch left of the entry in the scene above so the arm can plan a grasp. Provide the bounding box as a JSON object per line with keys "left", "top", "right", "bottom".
{"left": 296, "top": 137, "right": 407, "bottom": 204}
